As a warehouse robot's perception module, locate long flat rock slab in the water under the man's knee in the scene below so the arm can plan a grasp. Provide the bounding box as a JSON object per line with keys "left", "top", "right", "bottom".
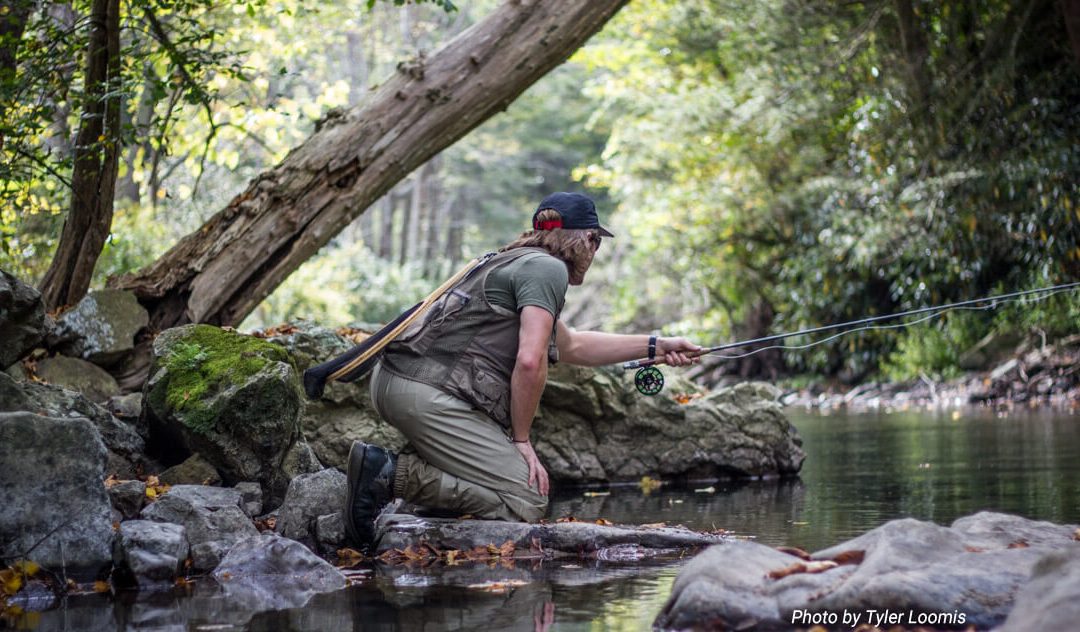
{"left": 376, "top": 513, "right": 723, "bottom": 562}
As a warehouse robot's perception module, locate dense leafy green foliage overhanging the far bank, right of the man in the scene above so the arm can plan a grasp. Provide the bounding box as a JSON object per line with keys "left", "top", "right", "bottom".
{"left": 582, "top": 0, "right": 1080, "bottom": 377}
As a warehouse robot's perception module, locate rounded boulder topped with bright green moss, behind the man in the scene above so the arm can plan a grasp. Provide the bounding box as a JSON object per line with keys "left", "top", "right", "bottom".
{"left": 143, "top": 325, "right": 320, "bottom": 507}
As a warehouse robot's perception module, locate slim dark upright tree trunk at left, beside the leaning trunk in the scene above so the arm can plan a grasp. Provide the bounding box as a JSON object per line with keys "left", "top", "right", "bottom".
{"left": 41, "top": 0, "right": 120, "bottom": 308}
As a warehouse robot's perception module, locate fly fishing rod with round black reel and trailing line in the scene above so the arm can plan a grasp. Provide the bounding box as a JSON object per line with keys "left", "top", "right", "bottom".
{"left": 622, "top": 282, "right": 1080, "bottom": 395}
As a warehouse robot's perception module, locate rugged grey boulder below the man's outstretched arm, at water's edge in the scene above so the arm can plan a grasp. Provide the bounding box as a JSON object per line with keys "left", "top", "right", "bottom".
{"left": 532, "top": 364, "right": 805, "bottom": 483}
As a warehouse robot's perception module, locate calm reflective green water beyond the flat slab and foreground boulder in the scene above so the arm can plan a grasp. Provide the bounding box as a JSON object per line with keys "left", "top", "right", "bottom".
{"left": 552, "top": 412, "right": 1080, "bottom": 551}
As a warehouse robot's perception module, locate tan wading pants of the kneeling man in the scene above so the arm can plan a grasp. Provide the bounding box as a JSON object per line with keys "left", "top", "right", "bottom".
{"left": 372, "top": 365, "right": 548, "bottom": 522}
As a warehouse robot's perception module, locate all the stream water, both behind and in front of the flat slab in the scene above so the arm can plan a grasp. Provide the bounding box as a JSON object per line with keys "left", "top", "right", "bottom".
{"left": 16, "top": 412, "right": 1080, "bottom": 631}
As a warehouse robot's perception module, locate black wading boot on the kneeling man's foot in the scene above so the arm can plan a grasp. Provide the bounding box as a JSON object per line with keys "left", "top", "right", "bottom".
{"left": 345, "top": 441, "right": 397, "bottom": 551}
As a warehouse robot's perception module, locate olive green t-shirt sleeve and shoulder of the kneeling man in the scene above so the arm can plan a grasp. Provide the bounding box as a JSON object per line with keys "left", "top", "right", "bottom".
{"left": 484, "top": 253, "right": 570, "bottom": 318}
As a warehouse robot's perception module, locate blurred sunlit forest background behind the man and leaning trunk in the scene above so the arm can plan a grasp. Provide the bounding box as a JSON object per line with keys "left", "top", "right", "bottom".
{"left": 0, "top": 0, "right": 1080, "bottom": 381}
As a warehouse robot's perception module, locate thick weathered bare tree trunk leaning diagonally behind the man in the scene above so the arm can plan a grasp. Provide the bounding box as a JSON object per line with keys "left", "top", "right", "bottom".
{"left": 113, "top": 0, "right": 626, "bottom": 328}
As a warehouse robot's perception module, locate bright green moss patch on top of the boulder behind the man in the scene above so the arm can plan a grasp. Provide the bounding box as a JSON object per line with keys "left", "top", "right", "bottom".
{"left": 163, "top": 325, "right": 295, "bottom": 434}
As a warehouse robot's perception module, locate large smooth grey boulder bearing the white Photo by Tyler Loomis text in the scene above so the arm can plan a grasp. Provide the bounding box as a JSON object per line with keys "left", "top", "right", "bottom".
{"left": 654, "top": 512, "right": 1078, "bottom": 630}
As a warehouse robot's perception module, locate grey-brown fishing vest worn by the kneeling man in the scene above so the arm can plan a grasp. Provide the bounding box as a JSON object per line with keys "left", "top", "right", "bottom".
{"left": 381, "top": 247, "right": 558, "bottom": 428}
